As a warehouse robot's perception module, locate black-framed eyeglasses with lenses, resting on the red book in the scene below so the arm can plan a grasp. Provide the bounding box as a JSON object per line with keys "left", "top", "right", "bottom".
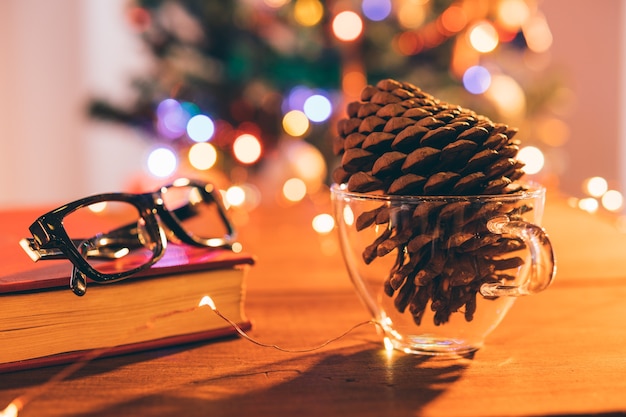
{"left": 20, "top": 178, "right": 235, "bottom": 295}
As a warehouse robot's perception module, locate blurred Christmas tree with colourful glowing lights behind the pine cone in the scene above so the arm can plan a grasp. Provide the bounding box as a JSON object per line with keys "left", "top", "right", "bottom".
{"left": 91, "top": 0, "right": 566, "bottom": 202}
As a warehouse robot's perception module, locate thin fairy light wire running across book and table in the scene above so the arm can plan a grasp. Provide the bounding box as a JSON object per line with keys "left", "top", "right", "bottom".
{"left": 0, "top": 295, "right": 380, "bottom": 417}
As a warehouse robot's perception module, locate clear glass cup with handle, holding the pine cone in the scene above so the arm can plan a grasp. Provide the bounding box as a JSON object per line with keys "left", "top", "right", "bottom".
{"left": 331, "top": 184, "right": 556, "bottom": 355}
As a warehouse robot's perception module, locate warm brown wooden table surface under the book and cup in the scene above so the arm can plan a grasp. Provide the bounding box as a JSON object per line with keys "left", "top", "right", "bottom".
{"left": 0, "top": 188, "right": 626, "bottom": 417}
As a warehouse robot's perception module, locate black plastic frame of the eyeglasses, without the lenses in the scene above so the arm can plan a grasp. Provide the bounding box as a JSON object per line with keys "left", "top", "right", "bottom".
{"left": 20, "top": 178, "right": 236, "bottom": 295}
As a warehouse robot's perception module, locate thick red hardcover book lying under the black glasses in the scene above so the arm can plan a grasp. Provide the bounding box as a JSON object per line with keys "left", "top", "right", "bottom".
{"left": 0, "top": 211, "right": 254, "bottom": 372}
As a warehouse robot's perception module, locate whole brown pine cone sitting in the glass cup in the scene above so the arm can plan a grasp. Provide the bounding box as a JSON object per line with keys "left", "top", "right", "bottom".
{"left": 333, "top": 79, "right": 532, "bottom": 325}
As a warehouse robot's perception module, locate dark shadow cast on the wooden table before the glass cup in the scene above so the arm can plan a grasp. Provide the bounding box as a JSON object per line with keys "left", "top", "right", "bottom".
{"left": 66, "top": 347, "right": 470, "bottom": 416}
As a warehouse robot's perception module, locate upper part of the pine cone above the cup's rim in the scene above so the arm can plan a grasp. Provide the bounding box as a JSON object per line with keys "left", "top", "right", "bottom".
{"left": 333, "top": 79, "right": 523, "bottom": 195}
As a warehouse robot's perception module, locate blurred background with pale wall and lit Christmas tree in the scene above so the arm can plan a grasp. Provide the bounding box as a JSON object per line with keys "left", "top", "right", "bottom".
{"left": 0, "top": 0, "right": 626, "bottom": 221}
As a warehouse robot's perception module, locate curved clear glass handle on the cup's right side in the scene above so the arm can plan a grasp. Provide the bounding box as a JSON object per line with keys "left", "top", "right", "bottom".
{"left": 480, "top": 216, "right": 556, "bottom": 297}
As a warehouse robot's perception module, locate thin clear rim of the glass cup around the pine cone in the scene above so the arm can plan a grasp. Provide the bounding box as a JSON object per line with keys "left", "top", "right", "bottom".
{"left": 330, "top": 181, "right": 546, "bottom": 204}
